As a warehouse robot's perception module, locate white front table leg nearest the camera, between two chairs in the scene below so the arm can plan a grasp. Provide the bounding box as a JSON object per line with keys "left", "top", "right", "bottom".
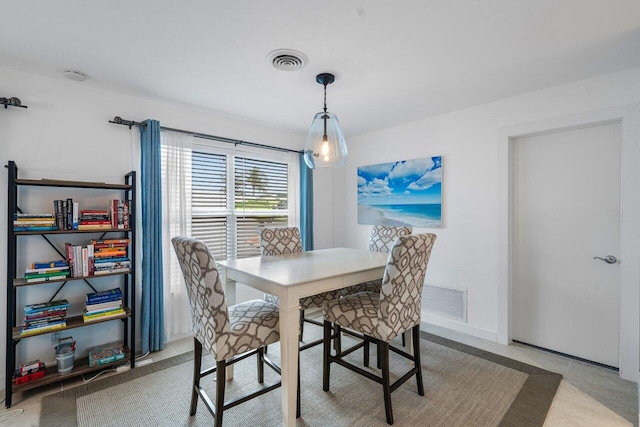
{"left": 280, "top": 298, "right": 300, "bottom": 426}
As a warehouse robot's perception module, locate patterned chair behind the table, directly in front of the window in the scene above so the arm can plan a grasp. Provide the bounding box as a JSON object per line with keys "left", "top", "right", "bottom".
{"left": 258, "top": 227, "right": 340, "bottom": 350}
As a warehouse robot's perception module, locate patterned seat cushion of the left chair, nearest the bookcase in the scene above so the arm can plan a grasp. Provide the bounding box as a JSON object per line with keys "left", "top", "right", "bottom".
{"left": 215, "top": 300, "right": 280, "bottom": 360}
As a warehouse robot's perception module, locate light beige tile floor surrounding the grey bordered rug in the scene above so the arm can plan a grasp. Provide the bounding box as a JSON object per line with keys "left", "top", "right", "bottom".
{"left": 0, "top": 325, "right": 638, "bottom": 427}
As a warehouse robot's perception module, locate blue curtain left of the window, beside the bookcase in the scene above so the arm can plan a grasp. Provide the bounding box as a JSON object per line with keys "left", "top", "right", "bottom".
{"left": 140, "top": 120, "right": 165, "bottom": 353}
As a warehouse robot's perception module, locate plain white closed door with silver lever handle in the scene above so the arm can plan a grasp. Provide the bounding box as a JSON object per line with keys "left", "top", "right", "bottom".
{"left": 512, "top": 123, "right": 622, "bottom": 367}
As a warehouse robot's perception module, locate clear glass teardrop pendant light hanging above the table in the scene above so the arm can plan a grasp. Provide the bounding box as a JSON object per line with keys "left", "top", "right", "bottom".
{"left": 304, "top": 73, "right": 348, "bottom": 169}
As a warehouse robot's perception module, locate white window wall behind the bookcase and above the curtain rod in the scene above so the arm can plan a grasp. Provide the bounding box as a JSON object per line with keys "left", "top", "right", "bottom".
{"left": 0, "top": 68, "right": 333, "bottom": 387}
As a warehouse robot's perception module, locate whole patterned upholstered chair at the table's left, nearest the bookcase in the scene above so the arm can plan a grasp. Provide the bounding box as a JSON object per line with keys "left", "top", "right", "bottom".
{"left": 171, "top": 237, "right": 288, "bottom": 426}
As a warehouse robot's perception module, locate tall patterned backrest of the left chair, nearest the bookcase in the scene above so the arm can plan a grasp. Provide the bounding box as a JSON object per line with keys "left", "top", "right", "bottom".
{"left": 171, "top": 237, "right": 229, "bottom": 360}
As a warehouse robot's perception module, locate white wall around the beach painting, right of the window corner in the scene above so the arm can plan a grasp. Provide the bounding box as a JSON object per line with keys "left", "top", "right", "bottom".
{"left": 334, "top": 69, "right": 640, "bottom": 348}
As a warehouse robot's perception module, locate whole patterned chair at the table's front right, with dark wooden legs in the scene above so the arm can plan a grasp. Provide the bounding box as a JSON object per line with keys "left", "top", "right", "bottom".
{"left": 323, "top": 234, "right": 436, "bottom": 424}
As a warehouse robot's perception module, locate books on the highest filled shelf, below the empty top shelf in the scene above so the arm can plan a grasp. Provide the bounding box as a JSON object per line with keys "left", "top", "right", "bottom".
{"left": 13, "top": 198, "right": 131, "bottom": 231}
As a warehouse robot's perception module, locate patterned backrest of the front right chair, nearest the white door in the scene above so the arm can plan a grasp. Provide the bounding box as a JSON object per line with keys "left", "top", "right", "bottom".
{"left": 378, "top": 233, "right": 436, "bottom": 340}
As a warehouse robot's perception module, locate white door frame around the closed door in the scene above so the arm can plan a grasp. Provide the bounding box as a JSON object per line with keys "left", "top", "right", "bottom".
{"left": 497, "top": 104, "right": 640, "bottom": 382}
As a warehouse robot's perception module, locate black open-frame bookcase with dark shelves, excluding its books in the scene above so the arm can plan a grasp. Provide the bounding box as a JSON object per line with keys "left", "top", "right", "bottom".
{"left": 5, "top": 161, "right": 136, "bottom": 408}
